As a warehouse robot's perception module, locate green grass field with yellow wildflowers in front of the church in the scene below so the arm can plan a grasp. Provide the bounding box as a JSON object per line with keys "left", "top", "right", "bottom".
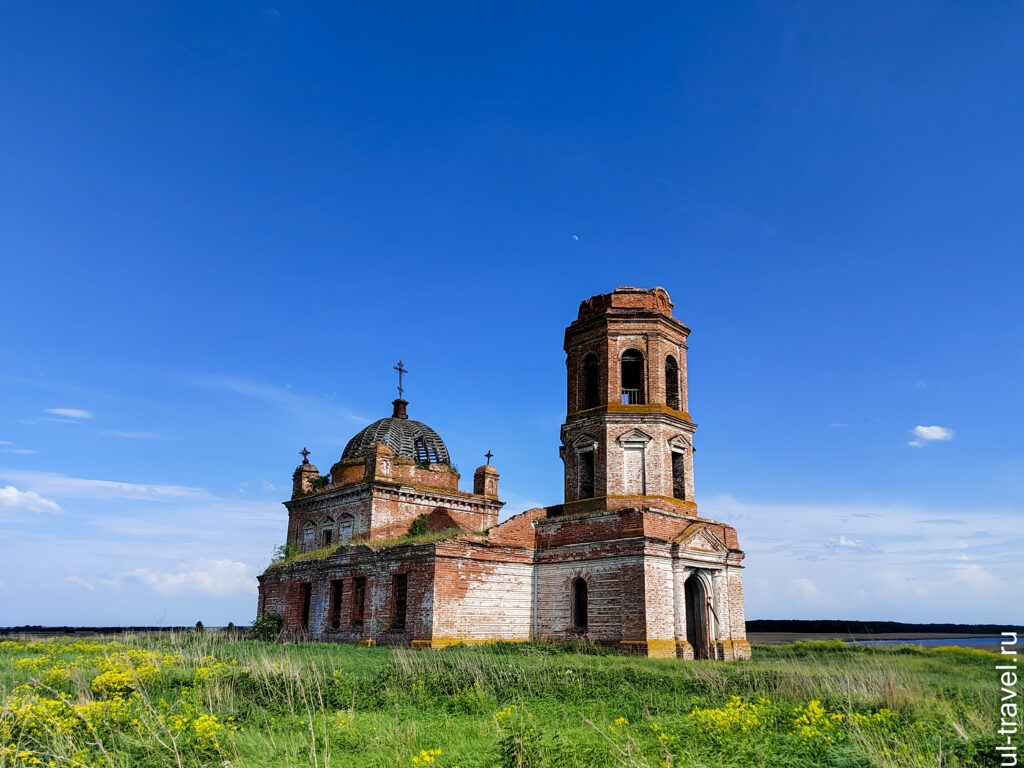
{"left": 0, "top": 632, "right": 998, "bottom": 768}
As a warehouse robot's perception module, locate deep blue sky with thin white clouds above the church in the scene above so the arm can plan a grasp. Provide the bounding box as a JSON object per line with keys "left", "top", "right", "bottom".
{"left": 0, "top": 2, "right": 1024, "bottom": 625}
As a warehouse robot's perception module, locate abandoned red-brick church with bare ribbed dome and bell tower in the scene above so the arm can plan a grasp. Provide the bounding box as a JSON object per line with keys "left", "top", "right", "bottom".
{"left": 259, "top": 288, "right": 750, "bottom": 659}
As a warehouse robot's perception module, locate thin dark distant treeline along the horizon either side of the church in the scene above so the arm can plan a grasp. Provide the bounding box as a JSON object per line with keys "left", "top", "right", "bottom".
{"left": 0, "top": 618, "right": 1024, "bottom": 635}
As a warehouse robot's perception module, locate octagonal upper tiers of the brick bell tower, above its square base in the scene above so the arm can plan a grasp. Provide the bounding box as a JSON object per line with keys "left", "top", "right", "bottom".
{"left": 559, "top": 288, "right": 697, "bottom": 517}
